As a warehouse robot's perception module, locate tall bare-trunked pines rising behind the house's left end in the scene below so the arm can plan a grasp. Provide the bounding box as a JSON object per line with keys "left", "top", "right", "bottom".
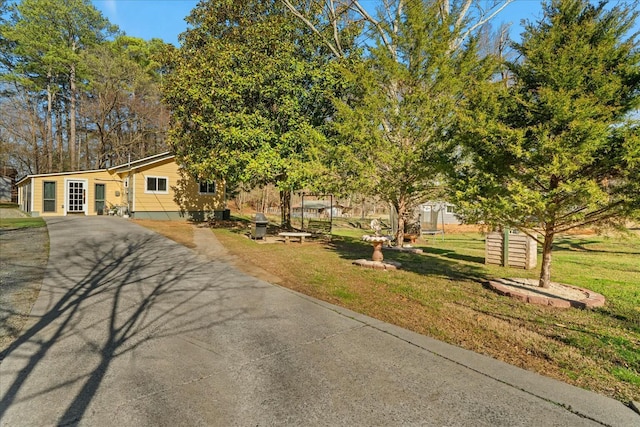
{"left": 0, "top": 0, "right": 117, "bottom": 172}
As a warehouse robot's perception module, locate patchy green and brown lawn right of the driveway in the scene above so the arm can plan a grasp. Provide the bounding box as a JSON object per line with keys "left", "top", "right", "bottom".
{"left": 215, "top": 229, "right": 640, "bottom": 402}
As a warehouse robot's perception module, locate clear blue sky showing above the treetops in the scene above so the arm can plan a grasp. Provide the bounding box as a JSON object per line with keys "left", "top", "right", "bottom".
{"left": 93, "top": 0, "right": 541, "bottom": 46}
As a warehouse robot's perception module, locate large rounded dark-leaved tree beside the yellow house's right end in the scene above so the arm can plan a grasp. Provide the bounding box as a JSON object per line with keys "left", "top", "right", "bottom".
{"left": 164, "top": 0, "right": 336, "bottom": 226}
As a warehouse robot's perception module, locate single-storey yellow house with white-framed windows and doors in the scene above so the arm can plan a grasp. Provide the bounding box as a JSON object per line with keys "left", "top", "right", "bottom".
{"left": 16, "top": 153, "right": 228, "bottom": 220}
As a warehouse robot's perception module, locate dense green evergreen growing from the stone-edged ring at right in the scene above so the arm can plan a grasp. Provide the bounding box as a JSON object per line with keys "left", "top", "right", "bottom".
{"left": 452, "top": 0, "right": 640, "bottom": 287}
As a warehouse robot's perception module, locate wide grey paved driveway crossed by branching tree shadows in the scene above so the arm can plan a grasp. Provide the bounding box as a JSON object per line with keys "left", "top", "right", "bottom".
{"left": 0, "top": 217, "right": 640, "bottom": 427}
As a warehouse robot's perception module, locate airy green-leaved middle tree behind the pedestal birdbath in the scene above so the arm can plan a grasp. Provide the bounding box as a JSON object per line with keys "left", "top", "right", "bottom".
{"left": 322, "top": 0, "right": 490, "bottom": 246}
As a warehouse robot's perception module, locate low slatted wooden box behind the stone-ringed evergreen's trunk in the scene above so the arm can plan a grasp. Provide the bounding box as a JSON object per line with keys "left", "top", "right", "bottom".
{"left": 485, "top": 231, "right": 538, "bottom": 270}
